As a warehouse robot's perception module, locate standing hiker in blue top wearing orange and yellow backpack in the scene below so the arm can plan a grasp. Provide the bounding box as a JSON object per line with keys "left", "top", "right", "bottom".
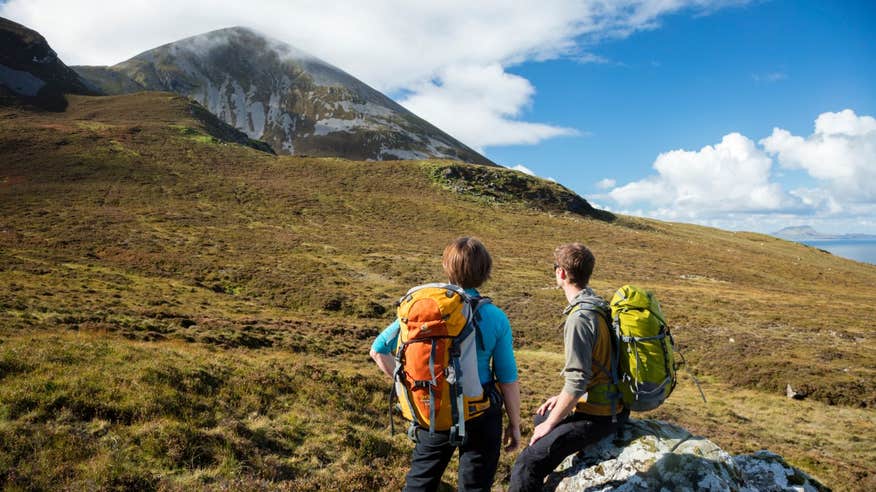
{"left": 370, "top": 237, "right": 520, "bottom": 491}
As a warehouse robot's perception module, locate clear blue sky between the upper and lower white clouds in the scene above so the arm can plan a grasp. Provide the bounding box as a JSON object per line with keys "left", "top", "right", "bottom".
{"left": 486, "top": 1, "right": 876, "bottom": 232}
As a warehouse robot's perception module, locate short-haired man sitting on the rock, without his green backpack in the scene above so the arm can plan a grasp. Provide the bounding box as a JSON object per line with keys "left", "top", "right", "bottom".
{"left": 509, "top": 243, "right": 629, "bottom": 492}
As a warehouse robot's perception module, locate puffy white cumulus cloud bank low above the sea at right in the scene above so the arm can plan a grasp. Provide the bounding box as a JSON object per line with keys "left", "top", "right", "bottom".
{"left": 599, "top": 109, "right": 876, "bottom": 232}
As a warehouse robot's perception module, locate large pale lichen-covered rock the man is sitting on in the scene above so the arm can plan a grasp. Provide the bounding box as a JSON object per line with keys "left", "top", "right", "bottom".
{"left": 545, "top": 419, "right": 830, "bottom": 492}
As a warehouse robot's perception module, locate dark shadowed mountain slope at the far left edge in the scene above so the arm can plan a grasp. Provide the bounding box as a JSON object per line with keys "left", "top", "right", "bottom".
{"left": 0, "top": 17, "right": 96, "bottom": 111}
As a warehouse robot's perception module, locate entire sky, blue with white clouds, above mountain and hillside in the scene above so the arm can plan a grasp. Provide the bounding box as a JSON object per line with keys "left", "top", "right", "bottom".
{"left": 0, "top": 0, "right": 876, "bottom": 234}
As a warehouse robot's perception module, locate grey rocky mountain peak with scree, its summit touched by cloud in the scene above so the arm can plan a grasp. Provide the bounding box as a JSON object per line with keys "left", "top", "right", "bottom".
{"left": 74, "top": 27, "right": 493, "bottom": 164}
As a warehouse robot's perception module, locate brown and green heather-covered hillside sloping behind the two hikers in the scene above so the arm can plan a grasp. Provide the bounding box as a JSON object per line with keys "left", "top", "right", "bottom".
{"left": 0, "top": 93, "right": 876, "bottom": 490}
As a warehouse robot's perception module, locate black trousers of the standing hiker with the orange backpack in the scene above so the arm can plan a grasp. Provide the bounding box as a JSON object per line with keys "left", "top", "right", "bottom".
{"left": 405, "top": 404, "right": 502, "bottom": 491}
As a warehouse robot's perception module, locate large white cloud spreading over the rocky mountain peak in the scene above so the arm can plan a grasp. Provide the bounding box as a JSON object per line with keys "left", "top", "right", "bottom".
{"left": 0, "top": 0, "right": 744, "bottom": 149}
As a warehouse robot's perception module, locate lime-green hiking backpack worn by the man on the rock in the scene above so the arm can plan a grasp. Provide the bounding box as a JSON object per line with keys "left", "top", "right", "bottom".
{"left": 611, "top": 285, "right": 678, "bottom": 412}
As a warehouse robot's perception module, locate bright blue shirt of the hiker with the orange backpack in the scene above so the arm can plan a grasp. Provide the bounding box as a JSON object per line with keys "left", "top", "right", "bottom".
{"left": 371, "top": 289, "right": 517, "bottom": 384}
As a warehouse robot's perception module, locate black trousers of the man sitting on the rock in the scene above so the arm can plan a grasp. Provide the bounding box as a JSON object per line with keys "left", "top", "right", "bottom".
{"left": 508, "top": 410, "right": 630, "bottom": 492}
